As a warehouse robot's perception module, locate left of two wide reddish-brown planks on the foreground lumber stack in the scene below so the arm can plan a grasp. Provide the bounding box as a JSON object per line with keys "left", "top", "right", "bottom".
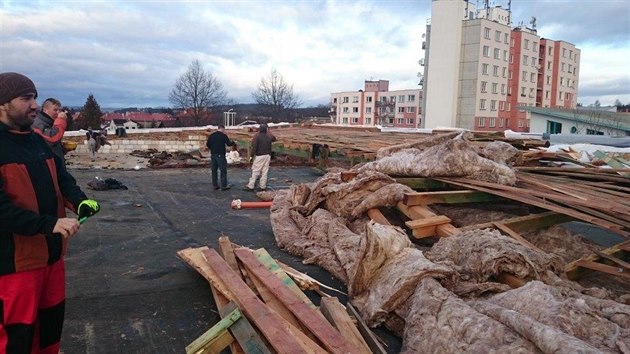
{"left": 202, "top": 249, "right": 307, "bottom": 353}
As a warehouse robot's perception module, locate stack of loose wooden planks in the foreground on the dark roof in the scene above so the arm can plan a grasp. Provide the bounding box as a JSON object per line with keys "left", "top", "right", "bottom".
{"left": 178, "top": 237, "right": 384, "bottom": 353}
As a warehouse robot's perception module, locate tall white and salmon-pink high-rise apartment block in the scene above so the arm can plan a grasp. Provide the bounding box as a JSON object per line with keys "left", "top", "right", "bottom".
{"left": 421, "top": 0, "right": 580, "bottom": 131}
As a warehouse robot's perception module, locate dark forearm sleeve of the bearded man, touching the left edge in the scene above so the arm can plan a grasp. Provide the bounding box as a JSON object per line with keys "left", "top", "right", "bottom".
{"left": 0, "top": 181, "right": 57, "bottom": 236}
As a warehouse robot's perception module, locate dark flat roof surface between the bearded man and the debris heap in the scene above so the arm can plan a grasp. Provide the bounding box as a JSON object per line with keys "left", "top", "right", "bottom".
{"left": 61, "top": 166, "right": 401, "bottom": 354}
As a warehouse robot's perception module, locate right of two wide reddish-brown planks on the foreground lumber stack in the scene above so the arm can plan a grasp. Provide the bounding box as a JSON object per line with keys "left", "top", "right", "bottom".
{"left": 234, "top": 249, "right": 358, "bottom": 353}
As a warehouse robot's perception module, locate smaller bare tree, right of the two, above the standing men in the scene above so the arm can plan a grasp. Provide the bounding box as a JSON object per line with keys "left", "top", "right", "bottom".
{"left": 252, "top": 68, "right": 302, "bottom": 118}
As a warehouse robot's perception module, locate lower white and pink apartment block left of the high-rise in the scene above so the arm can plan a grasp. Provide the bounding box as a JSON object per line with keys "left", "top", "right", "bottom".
{"left": 330, "top": 80, "right": 422, "bottom": 128}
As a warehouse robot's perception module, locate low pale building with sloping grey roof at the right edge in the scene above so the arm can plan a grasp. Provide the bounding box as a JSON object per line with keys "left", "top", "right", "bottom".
{"left": 518, "top": 106, "right": 630, "bottom": 136}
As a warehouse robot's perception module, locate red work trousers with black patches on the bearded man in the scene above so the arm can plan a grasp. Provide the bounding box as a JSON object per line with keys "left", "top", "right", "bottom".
{"left": 0, "top": 259, "right": 66, "bottom": 354}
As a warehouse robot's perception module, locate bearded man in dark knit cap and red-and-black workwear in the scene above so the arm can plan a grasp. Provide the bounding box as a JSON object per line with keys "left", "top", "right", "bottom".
{"left": 0, "top": 73, "right": 100, "bottom": 353}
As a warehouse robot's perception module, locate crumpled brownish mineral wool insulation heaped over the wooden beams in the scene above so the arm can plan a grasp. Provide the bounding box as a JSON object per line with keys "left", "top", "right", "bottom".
{"left": 271, "top": 136, "right": 630, "bottom": 353}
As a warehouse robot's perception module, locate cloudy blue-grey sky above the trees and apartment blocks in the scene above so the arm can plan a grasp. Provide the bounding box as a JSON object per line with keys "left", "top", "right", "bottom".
{"left": 0, "top": 0, "right": 630, "bottom": 108}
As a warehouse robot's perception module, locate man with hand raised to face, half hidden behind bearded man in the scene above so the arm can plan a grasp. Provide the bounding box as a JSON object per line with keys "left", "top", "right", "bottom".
{"left": 32, "top": 98, "right": 68, "bottom": 161}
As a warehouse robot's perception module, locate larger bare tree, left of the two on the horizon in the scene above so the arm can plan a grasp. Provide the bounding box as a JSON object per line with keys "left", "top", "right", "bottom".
{"left": 168, "top": 60, "right": 227, "bottom": 125}
